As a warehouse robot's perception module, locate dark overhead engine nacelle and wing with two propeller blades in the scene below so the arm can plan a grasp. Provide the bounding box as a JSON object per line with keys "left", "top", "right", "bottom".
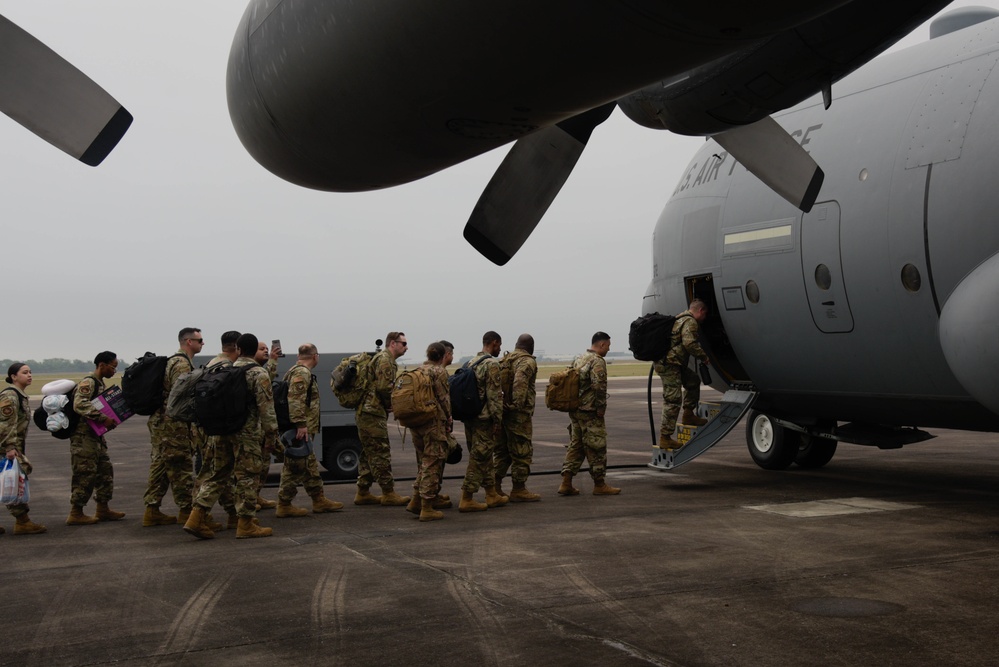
{"left": 226, "top": 0, "right": 949, "bottom": 264}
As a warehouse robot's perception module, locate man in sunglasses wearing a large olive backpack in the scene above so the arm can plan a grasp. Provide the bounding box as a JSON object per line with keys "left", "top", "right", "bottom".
{"left": 354, "top": 331, "right": 410, "bottom": 506}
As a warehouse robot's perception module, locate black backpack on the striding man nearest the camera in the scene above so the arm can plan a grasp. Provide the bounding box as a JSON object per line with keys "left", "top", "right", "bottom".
{"left": 194, "top": 364, "right": 253, "bottom": 435}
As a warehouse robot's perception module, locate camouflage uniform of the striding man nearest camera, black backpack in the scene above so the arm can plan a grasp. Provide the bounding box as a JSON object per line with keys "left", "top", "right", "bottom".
{"left": 194, "top": 357, "right": 278, "bottom": 518}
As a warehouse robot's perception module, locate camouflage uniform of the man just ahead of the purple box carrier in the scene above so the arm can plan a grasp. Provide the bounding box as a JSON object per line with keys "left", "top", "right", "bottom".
{"left": 142, "top": 350, "right": 196, "bottom": 512}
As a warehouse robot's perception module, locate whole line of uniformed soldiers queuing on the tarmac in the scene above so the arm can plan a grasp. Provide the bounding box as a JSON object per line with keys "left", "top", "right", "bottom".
{"left": 0, "top": 327, "right": 640, "bottom": 539}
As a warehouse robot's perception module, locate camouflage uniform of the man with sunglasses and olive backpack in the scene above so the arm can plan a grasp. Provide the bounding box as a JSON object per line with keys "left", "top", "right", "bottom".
{"left": 356, "top": 350, "right": 398, "bottom": 492}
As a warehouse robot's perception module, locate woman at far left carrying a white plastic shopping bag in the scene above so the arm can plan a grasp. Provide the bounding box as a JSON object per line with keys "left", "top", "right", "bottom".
{"left": 0, "top": 363, "right": 46, "bottom": 535}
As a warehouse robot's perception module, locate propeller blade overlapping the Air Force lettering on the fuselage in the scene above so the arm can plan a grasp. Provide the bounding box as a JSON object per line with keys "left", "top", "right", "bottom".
{"left": 711, "top": 116, "right": 825, "bottom": 213}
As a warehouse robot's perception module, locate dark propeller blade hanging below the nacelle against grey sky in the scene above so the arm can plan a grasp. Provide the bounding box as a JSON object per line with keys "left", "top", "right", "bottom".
{"left": 464, "top": 102, "right": 615, "bottom": 266}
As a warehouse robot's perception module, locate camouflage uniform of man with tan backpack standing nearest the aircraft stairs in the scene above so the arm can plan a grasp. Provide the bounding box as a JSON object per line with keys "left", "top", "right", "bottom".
{"left": 562, "top": 350, "right": 607, "bottom": 482}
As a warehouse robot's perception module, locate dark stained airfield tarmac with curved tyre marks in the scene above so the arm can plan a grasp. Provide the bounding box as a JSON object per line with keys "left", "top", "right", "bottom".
{"left": 7, "top": 378, "right": 999, "bottom": 667}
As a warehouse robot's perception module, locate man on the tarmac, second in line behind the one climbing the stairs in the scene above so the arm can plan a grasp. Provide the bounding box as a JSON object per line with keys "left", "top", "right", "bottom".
{"left": 495, "top": 334, "right": 541, "bottom": 503}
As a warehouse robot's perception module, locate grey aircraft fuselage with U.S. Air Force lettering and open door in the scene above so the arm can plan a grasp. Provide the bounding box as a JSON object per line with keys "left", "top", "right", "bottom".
{"left": 643, "top": 8, "right": 999, "bottom": 469}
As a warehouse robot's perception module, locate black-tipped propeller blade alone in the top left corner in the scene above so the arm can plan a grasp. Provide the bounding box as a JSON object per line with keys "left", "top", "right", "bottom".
{"left": 0, "top": 16, "right": 132, "bottom": 167}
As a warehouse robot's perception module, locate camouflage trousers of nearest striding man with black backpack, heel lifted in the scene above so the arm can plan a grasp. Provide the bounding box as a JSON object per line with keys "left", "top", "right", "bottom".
{"left": 194, "top": 434, "right": 264, "bottom": 517}
